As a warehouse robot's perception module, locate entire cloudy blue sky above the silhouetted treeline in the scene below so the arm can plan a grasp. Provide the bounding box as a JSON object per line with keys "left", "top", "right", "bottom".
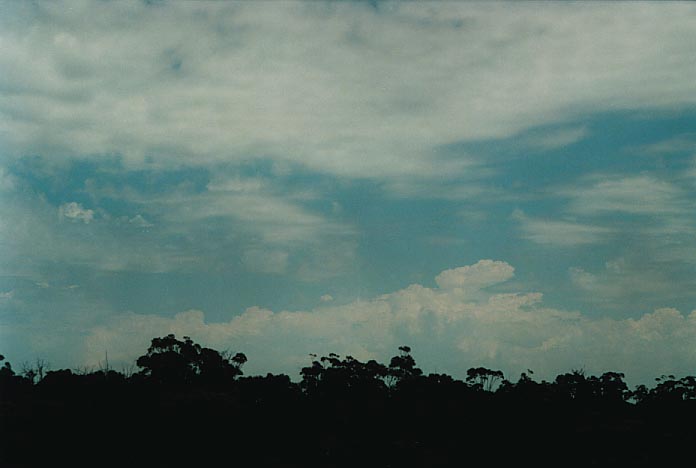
{"left": 0, "top": 1, "right": 696, "bottom": 384}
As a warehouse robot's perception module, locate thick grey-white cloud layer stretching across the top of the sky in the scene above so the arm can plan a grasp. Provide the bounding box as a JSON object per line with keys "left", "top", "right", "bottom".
{"left": 0, "top": 2, "right": 696, "bottom": 186}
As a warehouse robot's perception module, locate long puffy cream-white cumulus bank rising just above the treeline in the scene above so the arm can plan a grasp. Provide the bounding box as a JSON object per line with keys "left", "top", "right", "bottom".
{"left": 81, "top": 260, "right": 696, "bottom": 382}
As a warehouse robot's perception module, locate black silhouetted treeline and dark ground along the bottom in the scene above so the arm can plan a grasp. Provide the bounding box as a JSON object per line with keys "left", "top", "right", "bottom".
{"left": 0, "top": 335, "right": 696, "bottom": 467}
